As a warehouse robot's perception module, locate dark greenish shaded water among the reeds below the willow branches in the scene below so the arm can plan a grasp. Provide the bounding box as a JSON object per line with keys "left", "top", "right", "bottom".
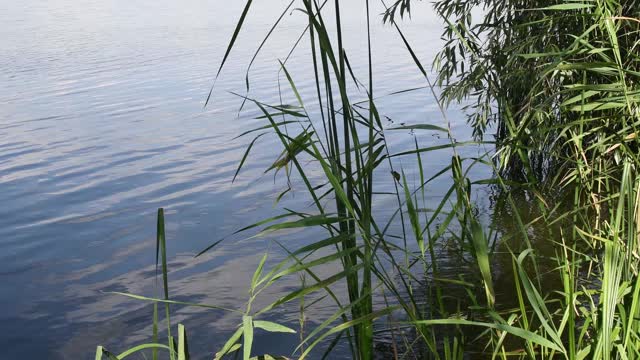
{"left": 376, "top": 186, "right": 587, "bottom": 359}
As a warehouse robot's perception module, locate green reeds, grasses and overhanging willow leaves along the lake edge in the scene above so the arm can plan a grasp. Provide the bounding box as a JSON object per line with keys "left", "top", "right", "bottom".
{"left": 96, "top": 0, "right": 640, "bottom": 360}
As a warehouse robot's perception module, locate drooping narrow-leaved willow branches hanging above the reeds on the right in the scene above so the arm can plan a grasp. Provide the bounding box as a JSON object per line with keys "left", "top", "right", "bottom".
{"left": 434, "top": 0, "right": 640, "bottom": 180}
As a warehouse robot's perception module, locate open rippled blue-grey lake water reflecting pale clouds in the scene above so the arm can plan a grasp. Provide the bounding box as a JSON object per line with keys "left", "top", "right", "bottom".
{"left": 0, "top": 0, "right": 490, "bottom": 359}
